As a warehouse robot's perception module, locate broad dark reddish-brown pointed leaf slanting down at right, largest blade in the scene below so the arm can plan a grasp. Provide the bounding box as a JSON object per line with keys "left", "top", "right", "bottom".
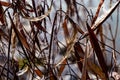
{"left": 86, "top": 23, "right": 108, "bottom": 78}
